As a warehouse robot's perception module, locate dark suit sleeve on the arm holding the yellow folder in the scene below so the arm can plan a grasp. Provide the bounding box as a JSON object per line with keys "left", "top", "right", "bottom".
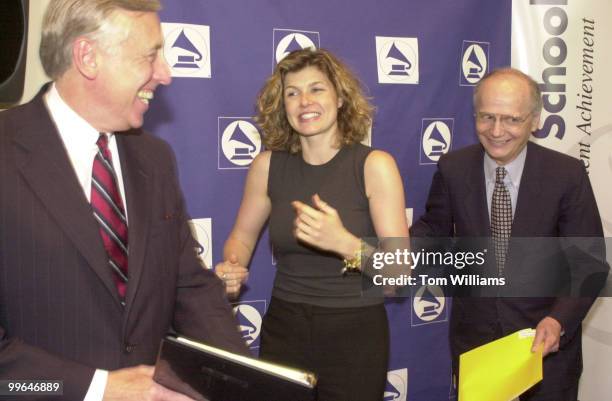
{"left": 550, "top": 162, "right": 609, "bottom": 345}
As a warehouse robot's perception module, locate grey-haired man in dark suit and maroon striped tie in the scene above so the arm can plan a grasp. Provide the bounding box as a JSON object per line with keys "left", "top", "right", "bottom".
{"left": 0, "top": 0, "right": 248, "bottom": 400}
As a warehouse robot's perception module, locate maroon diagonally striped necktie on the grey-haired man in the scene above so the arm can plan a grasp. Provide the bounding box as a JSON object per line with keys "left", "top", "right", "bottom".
{"left": 91, "top": 134, "right": 128, "bottom": 298}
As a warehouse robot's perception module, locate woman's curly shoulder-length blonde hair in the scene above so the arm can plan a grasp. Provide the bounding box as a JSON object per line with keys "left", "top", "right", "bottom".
{"left": 255, "top": 48, "right": 374, "bottom": 153}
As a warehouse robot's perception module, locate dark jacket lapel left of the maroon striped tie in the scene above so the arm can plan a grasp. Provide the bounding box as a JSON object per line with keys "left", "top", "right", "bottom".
{"left": 14, "top": 89, "right": 119, "bottom": 303}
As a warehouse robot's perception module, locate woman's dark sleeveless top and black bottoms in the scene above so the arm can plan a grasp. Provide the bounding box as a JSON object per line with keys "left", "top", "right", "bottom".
{"left": 260, "top": 144, "right": 389, "bottom": 401}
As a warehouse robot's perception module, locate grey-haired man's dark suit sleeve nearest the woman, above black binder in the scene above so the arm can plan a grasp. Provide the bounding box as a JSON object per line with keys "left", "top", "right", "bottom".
{"left": 160, "top": 142, "right": 250, "bottom": 356}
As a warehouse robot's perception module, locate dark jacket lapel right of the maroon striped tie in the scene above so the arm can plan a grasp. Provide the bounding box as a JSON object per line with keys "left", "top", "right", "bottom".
{"left": 117, "top": 131, "right": 154, "bottom": 308}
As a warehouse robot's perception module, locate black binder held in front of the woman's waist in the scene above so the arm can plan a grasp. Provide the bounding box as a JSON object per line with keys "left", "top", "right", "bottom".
{"left": 153, "top": 336, "right": 316, "bottom": 401}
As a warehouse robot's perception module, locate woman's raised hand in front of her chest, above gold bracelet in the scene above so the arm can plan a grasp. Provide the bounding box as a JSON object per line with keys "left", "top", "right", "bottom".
{"left": 291, "top": 194, "right": 360, "bottom": 257}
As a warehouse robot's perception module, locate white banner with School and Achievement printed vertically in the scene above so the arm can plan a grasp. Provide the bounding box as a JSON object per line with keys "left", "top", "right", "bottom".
{"left": 512, "top": 0, "right": 612, "bottom": 401}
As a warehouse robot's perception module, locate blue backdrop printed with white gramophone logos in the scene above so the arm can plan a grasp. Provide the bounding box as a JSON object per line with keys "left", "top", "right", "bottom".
{"left": 146, "top": 0, "right": 511, "bottom": 401}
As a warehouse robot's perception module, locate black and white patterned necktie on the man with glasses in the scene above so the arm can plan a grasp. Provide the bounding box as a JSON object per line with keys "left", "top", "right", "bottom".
{"left": 491, "top": 167, "right": 512, "bottom": 276}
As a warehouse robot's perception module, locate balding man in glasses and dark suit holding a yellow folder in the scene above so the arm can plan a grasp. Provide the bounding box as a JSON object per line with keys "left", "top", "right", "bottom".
{"left": 411, "top": 68, "right": 605, "bottom": 401}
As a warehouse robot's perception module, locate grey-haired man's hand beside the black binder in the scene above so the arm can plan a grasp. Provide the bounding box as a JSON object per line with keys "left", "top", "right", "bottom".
{"left": 103, "top": 365, "right": 193, "bottom": 401}
